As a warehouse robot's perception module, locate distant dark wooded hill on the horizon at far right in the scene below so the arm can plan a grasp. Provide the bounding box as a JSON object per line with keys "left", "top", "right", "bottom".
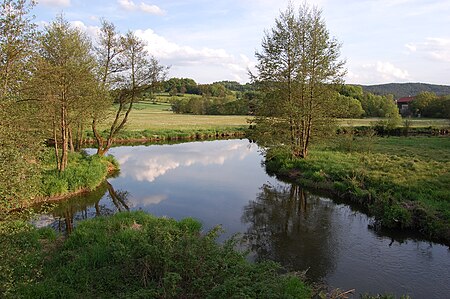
{"left": 361, "top": 83, "right": 450, "bottom": 98}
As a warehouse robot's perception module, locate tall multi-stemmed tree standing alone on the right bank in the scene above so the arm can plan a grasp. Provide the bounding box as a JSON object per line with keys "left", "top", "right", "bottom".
{"left": 252, "top": 4, "right": 345, "bottom": 158}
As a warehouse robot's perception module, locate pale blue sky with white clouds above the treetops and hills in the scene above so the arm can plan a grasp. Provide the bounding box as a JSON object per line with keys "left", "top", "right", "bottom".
{"left": 32, "top": 0, "right": 450, "bottom": 85}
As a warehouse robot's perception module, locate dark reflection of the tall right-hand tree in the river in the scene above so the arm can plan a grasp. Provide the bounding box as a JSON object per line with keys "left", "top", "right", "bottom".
{"left": 242, "top": 184, "right": 337, "bottom": 280}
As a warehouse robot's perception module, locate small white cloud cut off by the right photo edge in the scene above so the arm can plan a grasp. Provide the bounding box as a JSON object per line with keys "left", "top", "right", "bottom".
{"left": 405, "top": 37, "right": 450, "bottom": 63}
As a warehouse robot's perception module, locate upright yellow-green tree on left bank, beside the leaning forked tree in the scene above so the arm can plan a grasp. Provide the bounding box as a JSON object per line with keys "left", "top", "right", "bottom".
{"left": 30, "top": 16, "right": 98, "bottom": 171}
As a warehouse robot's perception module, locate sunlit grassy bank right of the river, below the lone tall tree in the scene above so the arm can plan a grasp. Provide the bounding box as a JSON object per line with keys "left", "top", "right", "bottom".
{"left": 266, "top": 136, "right": 450, "bottom": 244}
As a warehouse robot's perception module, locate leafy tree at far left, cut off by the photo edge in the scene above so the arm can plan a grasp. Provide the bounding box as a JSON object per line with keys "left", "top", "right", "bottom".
{"left": 0, "top": 0, "right": 42, "bottom": 211}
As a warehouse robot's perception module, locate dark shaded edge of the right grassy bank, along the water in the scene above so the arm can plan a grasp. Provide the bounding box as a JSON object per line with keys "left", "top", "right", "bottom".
{"left": 264, "top": 155, "right": 450, "bottom": 246}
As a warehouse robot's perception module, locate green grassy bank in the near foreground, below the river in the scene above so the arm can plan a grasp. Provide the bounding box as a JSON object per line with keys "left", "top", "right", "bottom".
{"left": 0, "top": 212, "right": 311, "bottom": 298}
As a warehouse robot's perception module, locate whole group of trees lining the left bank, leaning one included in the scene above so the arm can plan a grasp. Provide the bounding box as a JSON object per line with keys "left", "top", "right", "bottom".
{"left": 0, "top": 0, "right": 167, "bottom": 204}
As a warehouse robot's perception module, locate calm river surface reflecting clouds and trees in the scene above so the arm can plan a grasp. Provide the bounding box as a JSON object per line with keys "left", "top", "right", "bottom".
{"left": 37, "top": 140, "right": 450, "bottom": 298}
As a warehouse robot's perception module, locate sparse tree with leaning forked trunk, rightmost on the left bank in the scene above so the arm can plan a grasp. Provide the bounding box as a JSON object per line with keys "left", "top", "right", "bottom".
{"left": 92, "top": 21, "right": 167, "bottom": 156}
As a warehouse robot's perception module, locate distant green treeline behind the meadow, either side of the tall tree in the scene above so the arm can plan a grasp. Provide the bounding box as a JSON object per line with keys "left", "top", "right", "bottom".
{"left": 163, "top": 78, "right": 398, "bottom": 118}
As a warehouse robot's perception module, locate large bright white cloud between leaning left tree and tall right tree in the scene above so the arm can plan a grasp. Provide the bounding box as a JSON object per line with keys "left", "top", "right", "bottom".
{"left": 135, "top": 29, "right": 254, "bottom": 82}
